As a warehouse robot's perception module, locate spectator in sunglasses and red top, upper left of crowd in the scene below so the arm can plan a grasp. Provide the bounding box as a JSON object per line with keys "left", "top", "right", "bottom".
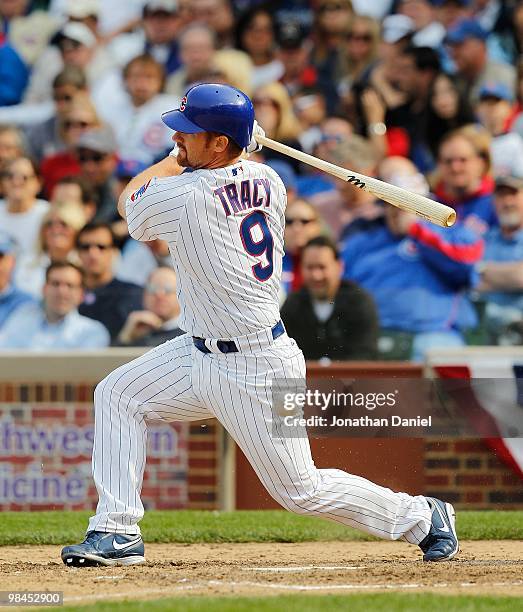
{"left": 40, "top": 92, "right": 101, "bottom": 197}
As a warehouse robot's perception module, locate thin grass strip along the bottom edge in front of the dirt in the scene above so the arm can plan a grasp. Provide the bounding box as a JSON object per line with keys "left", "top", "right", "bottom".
{"left": 42, "top": 593, "right": 523, "bottom": 612}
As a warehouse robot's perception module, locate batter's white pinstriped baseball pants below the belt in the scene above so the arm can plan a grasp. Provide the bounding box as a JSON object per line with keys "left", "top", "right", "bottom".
{"left": 88, "top": 334, "right": 431, "bottom": 544}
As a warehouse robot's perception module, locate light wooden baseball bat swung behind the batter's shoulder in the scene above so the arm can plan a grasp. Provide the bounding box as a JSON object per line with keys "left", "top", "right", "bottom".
{"left": 256, "top": 136, "right": 456, "bottom": 227}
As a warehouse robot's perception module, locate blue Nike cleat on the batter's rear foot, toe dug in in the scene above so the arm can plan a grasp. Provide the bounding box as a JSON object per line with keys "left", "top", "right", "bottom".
{"left": 419, "top": 497, "right": 459, "bottom": 561}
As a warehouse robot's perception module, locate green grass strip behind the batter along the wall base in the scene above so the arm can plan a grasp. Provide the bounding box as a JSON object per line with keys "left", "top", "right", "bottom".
{"left": 0, "top": 510, "right": 523, "bottom": 546}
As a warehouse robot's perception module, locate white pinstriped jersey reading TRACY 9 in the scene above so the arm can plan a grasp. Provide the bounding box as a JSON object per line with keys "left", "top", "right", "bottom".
{"left": 126, "top": 160, "right": 287, "bottom": 338}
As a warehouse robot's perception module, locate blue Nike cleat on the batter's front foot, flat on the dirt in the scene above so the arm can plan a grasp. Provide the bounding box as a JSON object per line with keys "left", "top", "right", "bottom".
{"left": 62, "top": 531, "right": 145, "bottom": 567}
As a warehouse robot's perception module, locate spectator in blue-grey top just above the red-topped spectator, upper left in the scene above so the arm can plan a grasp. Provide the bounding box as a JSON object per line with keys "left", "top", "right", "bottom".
{"left": 26, "top": 66, "right": 87, "bottom": 163}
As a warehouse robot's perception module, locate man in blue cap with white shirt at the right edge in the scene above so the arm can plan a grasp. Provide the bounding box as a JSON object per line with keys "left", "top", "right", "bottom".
{"left": 475, "top": 82, "right": 523, "bottom": 177}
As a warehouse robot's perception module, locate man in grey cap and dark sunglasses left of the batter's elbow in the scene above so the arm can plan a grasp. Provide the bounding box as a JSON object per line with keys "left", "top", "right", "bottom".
{"left": 76, "top": 125, "right": 119, "bottom": 223}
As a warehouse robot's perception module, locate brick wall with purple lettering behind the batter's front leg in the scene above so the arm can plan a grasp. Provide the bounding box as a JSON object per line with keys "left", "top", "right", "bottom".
{"left": 0, "top": 383, "right": 220, "bottom": 510}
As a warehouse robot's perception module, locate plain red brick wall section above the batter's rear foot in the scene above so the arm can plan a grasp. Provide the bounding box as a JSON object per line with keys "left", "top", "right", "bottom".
{"left": 425, "top": 439, "right": 523, "bottom": 510}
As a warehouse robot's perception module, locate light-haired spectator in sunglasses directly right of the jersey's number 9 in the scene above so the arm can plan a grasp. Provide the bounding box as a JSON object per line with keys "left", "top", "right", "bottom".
{"left": 281, "top": 198, "right": 322, "bottom": 295}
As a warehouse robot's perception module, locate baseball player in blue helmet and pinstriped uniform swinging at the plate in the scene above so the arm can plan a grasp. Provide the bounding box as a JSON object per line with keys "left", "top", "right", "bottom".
{"left": 62, "top": 84, "right": 458, "bottom": 567}
